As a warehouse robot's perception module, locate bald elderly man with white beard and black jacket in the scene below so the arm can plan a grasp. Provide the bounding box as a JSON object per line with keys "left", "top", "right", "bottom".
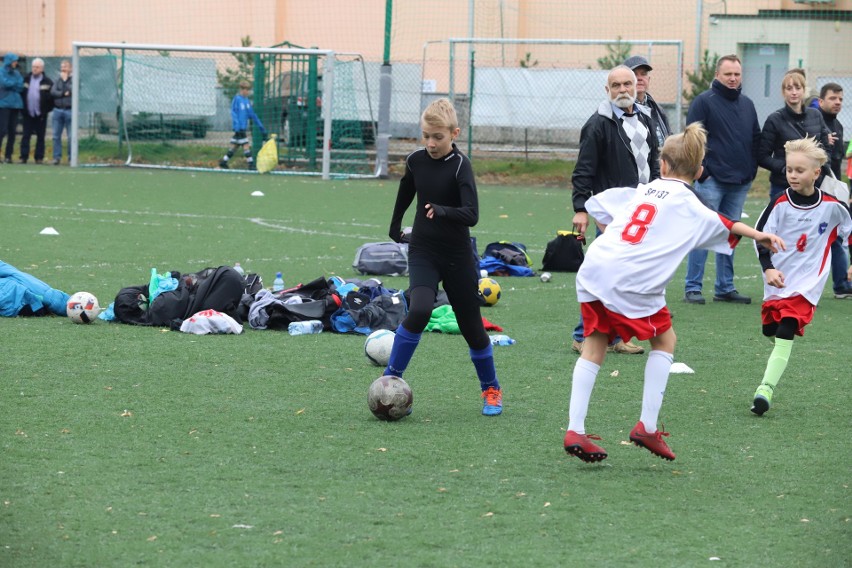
{"left": 571, "top": 65, "right": 660, "bottom": 354}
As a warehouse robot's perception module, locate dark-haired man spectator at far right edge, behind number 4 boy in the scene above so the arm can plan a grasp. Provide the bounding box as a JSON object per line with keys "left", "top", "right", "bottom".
{"left": 819, "top": 83, "right": 852, "bottom": 300}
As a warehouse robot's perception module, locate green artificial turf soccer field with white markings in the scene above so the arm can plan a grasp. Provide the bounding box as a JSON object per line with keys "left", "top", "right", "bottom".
{"left": 0, "top": 165, "right": 852, "bottom": 568}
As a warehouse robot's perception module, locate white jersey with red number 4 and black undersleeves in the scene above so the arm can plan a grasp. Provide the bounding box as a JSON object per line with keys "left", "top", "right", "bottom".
{"left": 755, "top": 188, "right": 852, "bottom": 306}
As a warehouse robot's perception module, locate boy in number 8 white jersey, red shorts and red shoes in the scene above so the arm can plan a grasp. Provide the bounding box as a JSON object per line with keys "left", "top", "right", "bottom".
{"left": 564, "top": 122, "right": 784, "bottom": 462}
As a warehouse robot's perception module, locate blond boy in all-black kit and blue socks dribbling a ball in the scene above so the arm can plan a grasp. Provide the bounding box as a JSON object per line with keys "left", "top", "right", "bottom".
{"left": 385, "top": 99, "right": 503, "bottom": 416}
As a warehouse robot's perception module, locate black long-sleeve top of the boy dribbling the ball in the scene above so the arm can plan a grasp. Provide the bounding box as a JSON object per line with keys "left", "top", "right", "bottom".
{"left": 389, "top": 144, "right": 479, "bottom": 254}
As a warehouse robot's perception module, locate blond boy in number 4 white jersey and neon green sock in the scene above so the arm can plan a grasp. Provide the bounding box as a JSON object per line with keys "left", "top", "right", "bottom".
{"left": 751, "top": 138, "right": 852, "bottom": 416}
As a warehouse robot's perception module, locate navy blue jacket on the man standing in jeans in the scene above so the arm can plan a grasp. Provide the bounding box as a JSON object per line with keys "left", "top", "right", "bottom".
{"left": 686, "top": 79, "right": 760, "bottom": 185}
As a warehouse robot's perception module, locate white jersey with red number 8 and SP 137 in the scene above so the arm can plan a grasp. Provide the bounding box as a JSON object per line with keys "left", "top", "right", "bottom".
{"left": 577, "top": 178, "right": 739, "bottom": 319}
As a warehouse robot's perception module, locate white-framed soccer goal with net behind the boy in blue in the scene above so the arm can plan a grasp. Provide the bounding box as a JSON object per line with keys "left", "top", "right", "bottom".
{"left": 72, "top": 42, "right": 375, "bottom": 179}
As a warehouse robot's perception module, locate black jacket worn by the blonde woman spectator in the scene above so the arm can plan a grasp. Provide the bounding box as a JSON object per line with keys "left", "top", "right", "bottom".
{"left": 757, "top": 105, "right": 829, "bottom": 187}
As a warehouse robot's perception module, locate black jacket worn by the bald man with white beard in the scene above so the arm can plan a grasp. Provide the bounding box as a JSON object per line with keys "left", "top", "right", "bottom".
{"left": 571, "top": 100, "right": 660, "bottom": 212}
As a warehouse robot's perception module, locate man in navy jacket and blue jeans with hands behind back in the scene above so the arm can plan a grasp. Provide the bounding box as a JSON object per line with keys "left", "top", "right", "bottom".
{"left": 684, "top": 55, "right": 760, "bottom": 304}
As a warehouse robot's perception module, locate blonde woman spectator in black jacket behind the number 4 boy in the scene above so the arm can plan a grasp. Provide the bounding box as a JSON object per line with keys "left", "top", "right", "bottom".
{"left": 757, "top": 69, "right": 830, "bottom": 203}
